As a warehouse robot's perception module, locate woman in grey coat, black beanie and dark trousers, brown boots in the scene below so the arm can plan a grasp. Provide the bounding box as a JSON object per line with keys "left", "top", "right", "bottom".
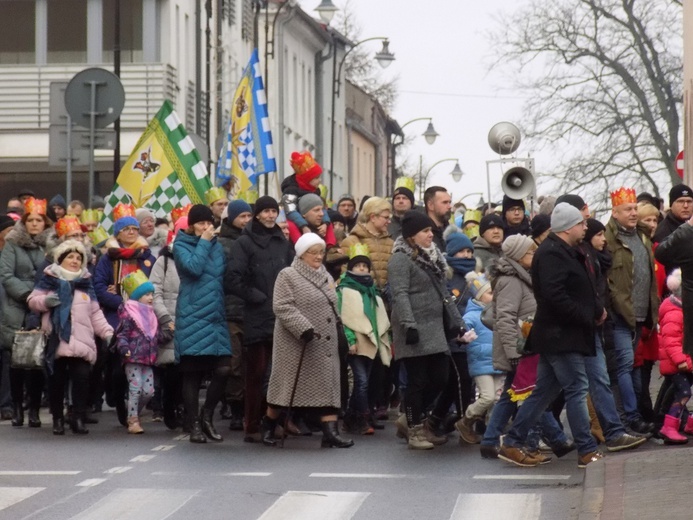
{"left": 388, "top": 210, "right": 462, "bottom": 449}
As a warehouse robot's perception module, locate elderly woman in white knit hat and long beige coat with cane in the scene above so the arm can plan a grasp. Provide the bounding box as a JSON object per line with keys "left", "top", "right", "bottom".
{"left": 262, "top": 233, "right": 354, "bottom": 448}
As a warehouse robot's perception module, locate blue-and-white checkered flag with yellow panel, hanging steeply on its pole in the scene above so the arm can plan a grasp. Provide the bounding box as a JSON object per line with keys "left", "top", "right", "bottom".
{"left": 216, "top": 49, "right": 277, "bottom": 195}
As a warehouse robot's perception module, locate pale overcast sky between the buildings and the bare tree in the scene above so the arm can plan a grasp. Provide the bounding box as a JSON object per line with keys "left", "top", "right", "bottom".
{"left": 300, "top": 0, "right": 528, "bottom": 204}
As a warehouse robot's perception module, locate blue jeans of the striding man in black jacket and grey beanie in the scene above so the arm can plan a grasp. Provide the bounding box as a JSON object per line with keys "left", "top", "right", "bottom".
{"left": 504, "top": 353, "right": 597, "bottom": 455}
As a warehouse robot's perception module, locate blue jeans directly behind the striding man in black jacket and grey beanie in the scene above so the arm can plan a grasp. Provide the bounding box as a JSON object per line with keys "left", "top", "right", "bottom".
{"left": 585, "top": 334, "right": 626, "bottom": 441}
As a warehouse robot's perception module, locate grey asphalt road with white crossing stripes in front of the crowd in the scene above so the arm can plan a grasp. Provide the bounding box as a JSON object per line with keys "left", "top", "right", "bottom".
{"left": 0, "top": 410, "right": 584, "bottom": 520}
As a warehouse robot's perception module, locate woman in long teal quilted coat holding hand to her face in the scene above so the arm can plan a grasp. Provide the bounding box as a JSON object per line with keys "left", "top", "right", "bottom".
{"left": 173, "top": 204, "right": 231, "bottom": 443}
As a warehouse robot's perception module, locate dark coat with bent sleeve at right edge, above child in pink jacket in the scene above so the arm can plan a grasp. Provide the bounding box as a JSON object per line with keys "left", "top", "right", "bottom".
{"left": 656, "top": 225, "right": 693, "bottom": 355}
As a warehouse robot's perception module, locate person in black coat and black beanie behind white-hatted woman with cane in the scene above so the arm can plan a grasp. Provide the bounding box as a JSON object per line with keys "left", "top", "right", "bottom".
{"left": 225, "top": 196, "right": 294, "bottom": 442}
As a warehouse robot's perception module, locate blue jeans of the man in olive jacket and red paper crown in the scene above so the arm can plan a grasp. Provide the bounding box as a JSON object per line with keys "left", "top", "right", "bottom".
{"left": 614, "top": 315, "right": 641, "bottom": 423}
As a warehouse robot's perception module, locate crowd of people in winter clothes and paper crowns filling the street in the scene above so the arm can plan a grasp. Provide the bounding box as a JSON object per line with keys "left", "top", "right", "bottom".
{"left": 0, "top": 152, "right": 693, "bottom": 467}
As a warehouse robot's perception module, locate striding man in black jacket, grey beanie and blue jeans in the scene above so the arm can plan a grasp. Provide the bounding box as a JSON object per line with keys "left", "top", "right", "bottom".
{"left": 498, "top": 203, "right": 606, "bottom": 467}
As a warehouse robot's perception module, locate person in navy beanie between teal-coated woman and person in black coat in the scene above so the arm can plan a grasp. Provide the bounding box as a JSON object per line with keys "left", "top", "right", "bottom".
{"left": 219, "top": 199, "right": 253, "bottom": 430}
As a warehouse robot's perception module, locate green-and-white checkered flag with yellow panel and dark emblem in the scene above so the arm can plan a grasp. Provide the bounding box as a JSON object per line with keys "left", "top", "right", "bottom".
{"left": 101, "top": 100, "right": 212, "bottom": 233}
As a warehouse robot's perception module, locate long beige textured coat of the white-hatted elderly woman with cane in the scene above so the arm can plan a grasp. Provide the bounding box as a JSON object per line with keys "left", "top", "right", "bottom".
{"left": 267, "top": 258, "right": 341, "bottom": 408}
